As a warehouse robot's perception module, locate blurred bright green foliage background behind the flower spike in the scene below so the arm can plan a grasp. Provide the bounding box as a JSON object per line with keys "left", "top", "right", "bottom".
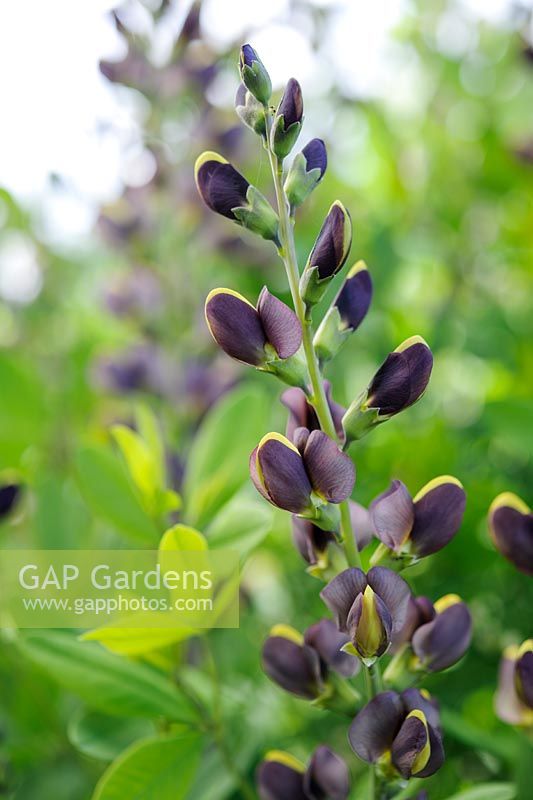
{"left": 0, "top": 2, "right": 533, "bottom": 800}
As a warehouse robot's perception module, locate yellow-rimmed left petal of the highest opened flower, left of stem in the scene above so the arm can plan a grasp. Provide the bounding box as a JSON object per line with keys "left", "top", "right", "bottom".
{"left": 205, "top": 289, "right": 266, "bottom": 366}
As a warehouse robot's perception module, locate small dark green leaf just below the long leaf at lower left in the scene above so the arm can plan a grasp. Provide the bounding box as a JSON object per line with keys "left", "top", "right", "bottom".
{"left": 68, "top": 709, "right": 155, "bottom": 761}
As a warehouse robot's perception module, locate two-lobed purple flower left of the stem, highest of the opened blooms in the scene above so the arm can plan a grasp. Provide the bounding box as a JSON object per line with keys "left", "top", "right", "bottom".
{"left": 205, "top": 287, "right": 302, "bottom": 367}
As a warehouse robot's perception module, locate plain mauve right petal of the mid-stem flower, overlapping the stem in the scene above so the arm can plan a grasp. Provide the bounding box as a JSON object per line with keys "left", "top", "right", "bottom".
{"left": 304, "top": 431, "right": 355, "bottom": 503}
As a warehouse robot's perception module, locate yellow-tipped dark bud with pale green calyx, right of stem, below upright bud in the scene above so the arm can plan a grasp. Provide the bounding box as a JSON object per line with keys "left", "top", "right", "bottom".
{"left": 313, "top": 261, "right": 372, "bottom": 362}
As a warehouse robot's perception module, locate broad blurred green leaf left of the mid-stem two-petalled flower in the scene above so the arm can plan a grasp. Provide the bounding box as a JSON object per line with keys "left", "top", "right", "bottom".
{"left": 184, "top": 386, "right": 268, "bottom": 528}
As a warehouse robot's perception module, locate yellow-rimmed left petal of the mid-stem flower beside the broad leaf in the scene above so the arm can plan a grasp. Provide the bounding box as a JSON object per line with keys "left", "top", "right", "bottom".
{"left": 257, "top": 435, "right": 311, "bottom": 514}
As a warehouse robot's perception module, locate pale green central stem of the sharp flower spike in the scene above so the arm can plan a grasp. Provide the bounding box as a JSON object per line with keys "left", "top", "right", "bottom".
{"left": 265, "top": 125, "right": 362, "bottom": 567}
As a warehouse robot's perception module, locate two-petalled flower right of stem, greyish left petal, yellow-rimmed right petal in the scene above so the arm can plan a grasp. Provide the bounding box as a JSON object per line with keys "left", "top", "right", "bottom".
{"left": 370, "top": 475, "right": 466, "bottom": 565}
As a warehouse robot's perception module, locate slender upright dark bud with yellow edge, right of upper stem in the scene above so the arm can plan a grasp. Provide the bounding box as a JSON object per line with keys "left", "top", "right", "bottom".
{"left": 300, "top": 200, "right": 352, "bottom": 306}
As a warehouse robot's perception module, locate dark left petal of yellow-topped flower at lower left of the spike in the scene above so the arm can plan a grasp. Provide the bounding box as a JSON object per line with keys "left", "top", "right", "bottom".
{"left": 262, "top": 636, "right": 324, "bottom": 700}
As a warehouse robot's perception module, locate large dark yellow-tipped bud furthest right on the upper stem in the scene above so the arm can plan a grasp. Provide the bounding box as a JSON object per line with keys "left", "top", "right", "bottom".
{"left": 365, "top": 336, "right": 433, "bottom": 417}
